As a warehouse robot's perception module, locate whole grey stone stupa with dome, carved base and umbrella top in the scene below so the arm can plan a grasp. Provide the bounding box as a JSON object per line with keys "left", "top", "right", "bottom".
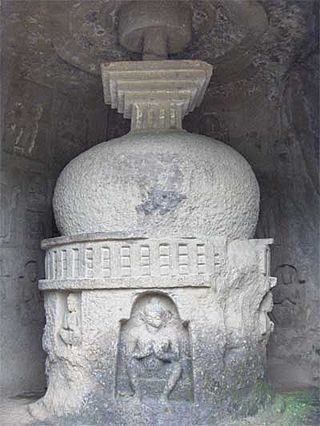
{"left": 30, "top": 1, "right": 276, "bottom": 425}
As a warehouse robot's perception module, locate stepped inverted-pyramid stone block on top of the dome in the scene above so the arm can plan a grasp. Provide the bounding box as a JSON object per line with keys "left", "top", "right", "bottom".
{"left": 101, "top": 60, "right": 212, "bottom": 124}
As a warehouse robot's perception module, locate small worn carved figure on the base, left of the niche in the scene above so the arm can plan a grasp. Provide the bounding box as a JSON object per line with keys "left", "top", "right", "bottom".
{"left": 59, "top": 293, "right": 81, "bottom": 347}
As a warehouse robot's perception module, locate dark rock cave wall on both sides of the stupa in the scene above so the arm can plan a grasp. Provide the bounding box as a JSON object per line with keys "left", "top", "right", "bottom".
{"left": 0, "top": 0, "right": 320, "bottom": 394}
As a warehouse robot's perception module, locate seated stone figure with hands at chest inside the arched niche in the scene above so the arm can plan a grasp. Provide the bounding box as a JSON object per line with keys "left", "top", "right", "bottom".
{"left": 127, "top": 298, "right": 182, "bottom": 400}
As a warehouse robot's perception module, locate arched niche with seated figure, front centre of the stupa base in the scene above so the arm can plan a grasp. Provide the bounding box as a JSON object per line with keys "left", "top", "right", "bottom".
{"left": 116, "top": 293, "right": 193, "bottom": 400}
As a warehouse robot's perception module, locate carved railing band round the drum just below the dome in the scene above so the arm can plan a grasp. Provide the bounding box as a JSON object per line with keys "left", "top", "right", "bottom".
{"left": 40, "top": 233, "right": 272, "bottom": 290}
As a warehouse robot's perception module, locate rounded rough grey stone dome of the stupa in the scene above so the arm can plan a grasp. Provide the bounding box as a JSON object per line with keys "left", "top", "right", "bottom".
{"left": 53, "top": 131, "right": 259, "bottom": 239}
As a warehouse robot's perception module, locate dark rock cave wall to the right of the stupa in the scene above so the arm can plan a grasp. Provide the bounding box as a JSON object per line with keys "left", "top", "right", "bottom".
{"left": 182, "top": 1, "right": 320, "bottom": 387}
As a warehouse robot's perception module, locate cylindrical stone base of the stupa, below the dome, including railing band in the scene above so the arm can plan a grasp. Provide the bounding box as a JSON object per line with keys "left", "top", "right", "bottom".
{"left": 32, "top": 233, "right": 275, "bottom": 424}
